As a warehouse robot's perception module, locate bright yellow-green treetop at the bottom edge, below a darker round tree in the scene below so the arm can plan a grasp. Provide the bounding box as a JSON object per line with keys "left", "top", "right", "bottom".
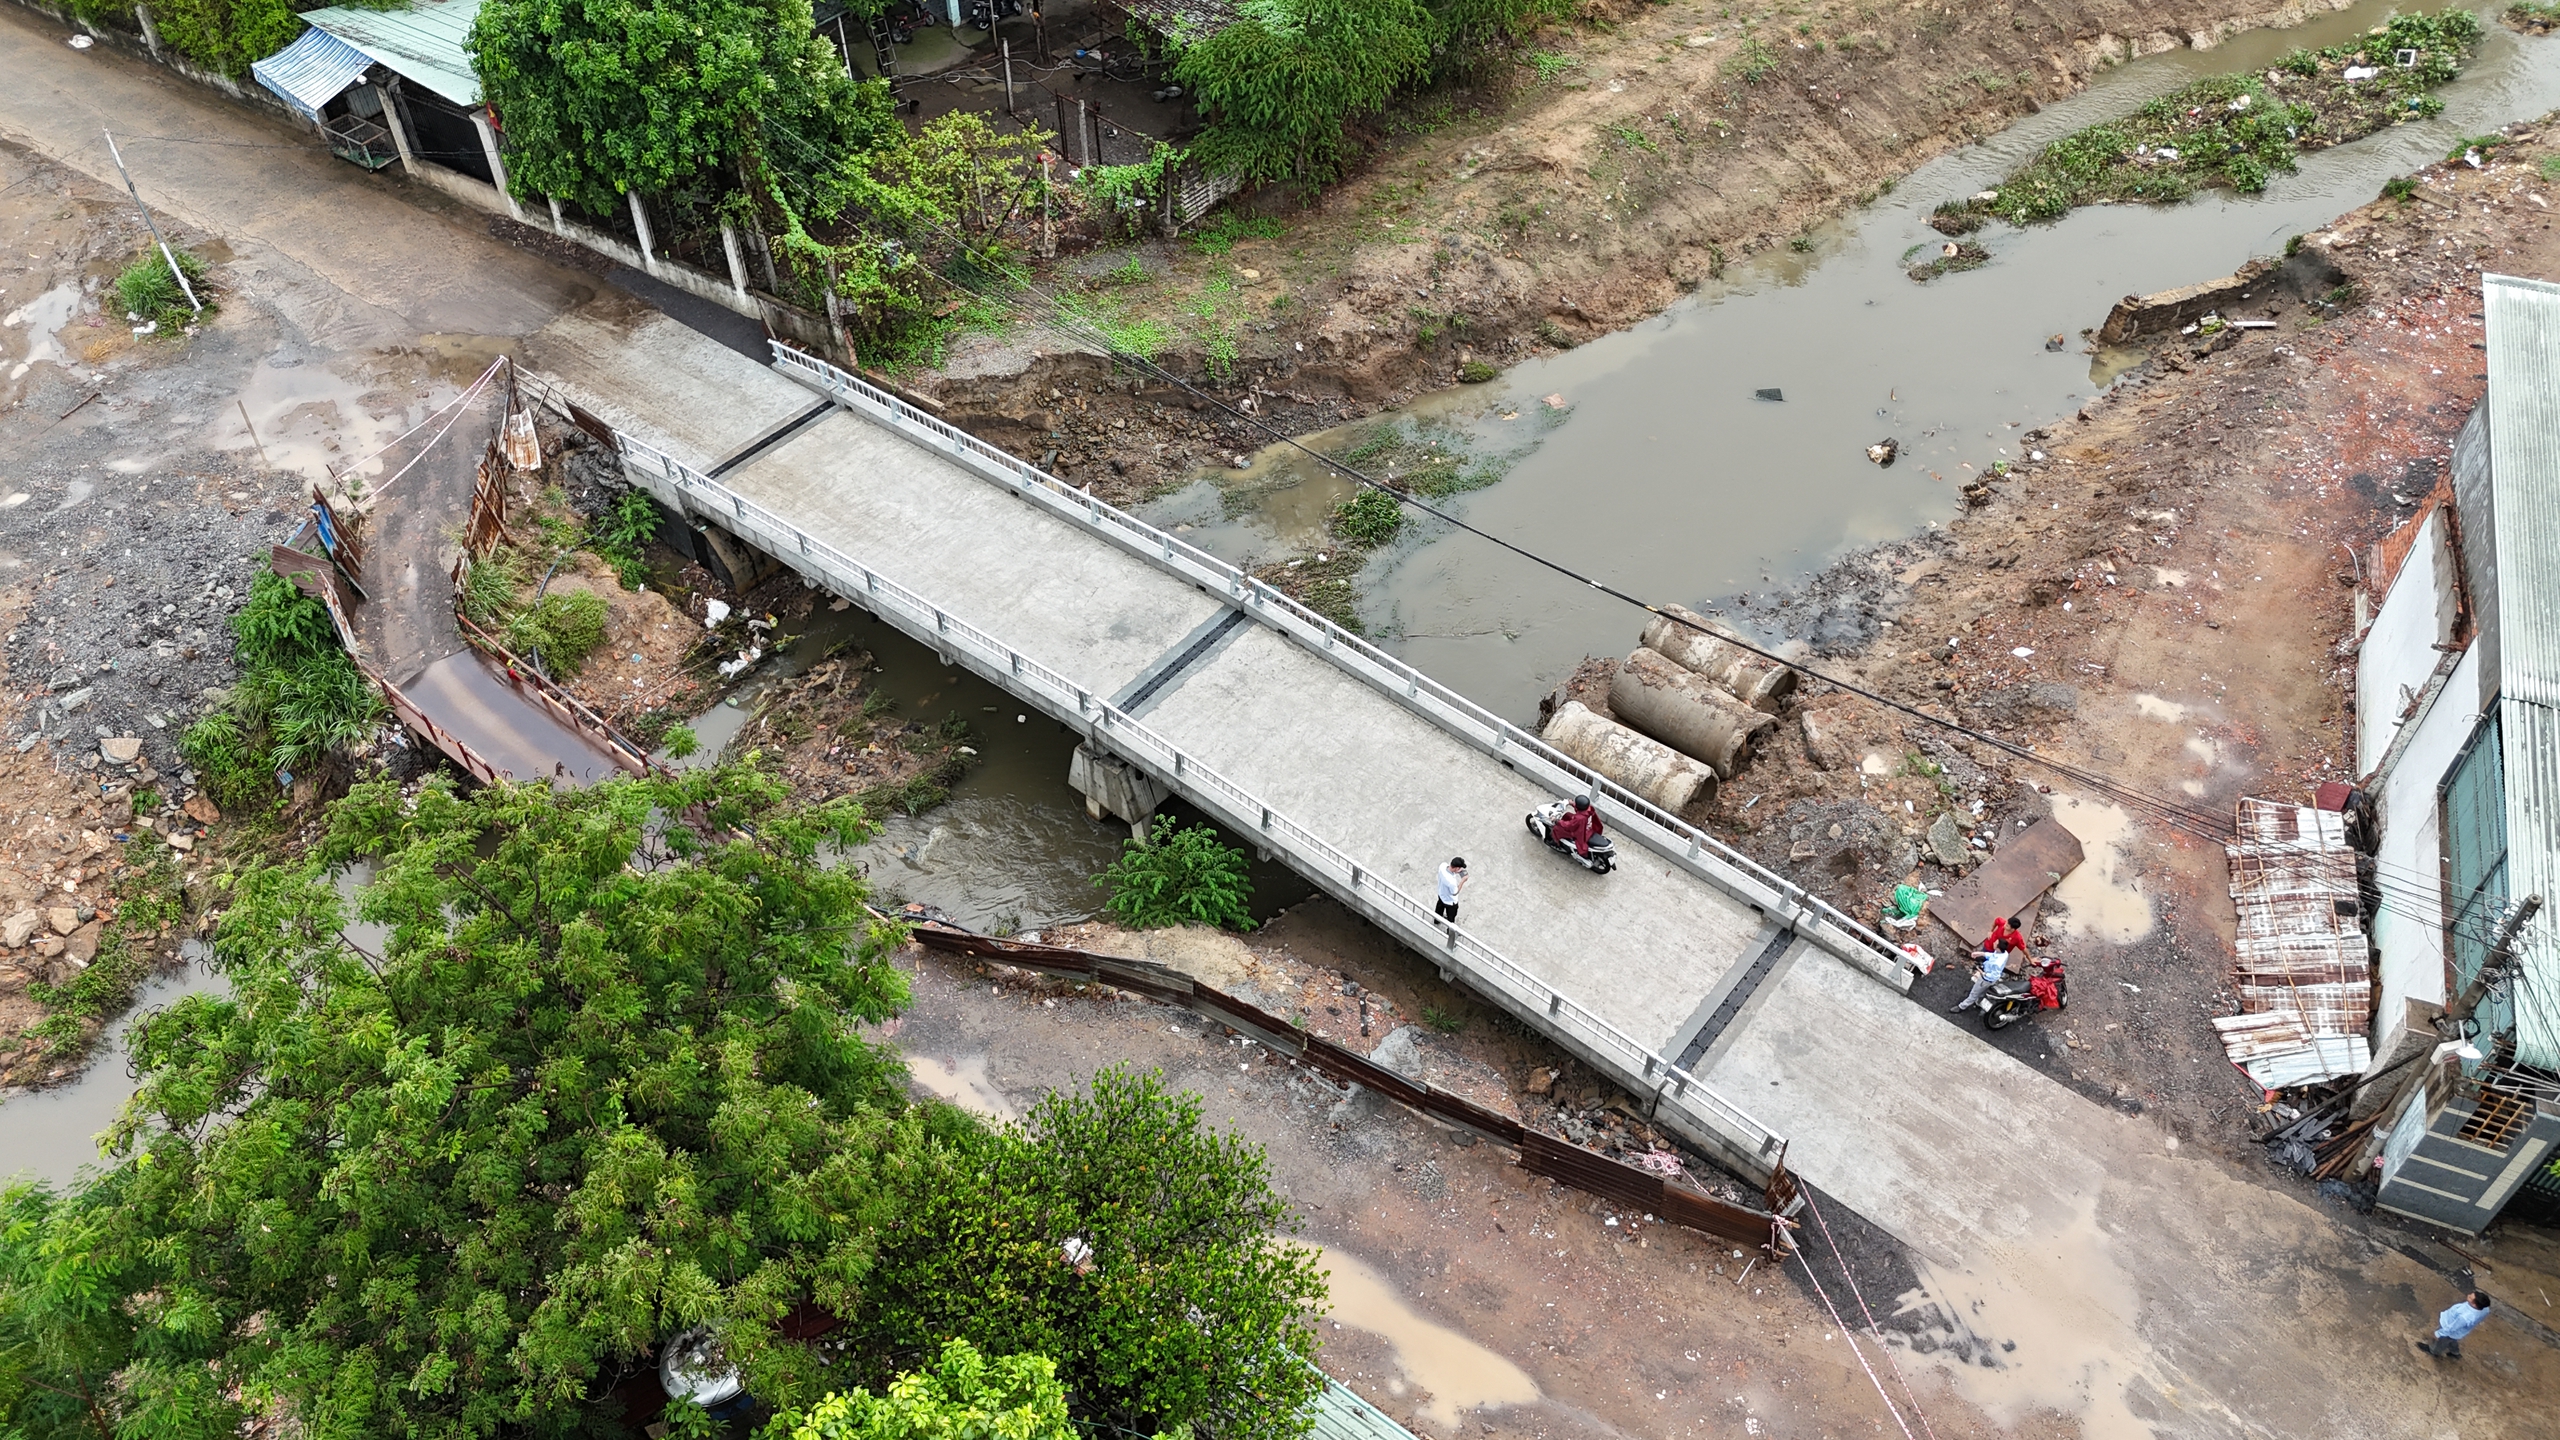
{"left": 768, "top": 1340, "right": 1075, "bottom": 1440}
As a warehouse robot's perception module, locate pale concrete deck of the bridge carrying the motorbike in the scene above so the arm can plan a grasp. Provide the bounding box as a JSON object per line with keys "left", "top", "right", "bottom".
{"left": 525, "top": 318, "right": 2007, "bottom": 1214}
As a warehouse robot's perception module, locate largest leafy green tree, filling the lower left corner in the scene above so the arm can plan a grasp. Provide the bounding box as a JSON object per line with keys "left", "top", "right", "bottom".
{"left": 0, "top": 766, "right": 919, "bottom": 1437}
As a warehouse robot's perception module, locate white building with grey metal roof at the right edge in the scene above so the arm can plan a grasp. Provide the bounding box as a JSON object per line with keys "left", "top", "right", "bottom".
{"left": 2355, "top": 274, "right": 2560, "bottom": 1232}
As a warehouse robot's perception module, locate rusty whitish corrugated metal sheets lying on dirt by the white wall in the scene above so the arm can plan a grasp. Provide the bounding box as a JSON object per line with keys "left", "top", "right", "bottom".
{"left": 2214, "top": 799, "right": 2373, "bottom": 1089}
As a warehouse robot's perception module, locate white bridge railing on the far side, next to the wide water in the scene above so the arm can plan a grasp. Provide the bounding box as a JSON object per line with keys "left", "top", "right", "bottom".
{"left": 773, "top": 341, "right": 1910, "bottom": 984}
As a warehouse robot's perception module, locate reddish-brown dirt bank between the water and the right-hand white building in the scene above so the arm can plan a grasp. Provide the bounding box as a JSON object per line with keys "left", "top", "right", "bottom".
{"left": 1631, "top": 123, "right": 2560, "bottom": 1166}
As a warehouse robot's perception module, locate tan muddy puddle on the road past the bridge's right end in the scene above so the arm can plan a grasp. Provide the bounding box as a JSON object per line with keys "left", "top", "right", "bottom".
{"left": 1900, "top": 1197, "right": 2176, "bottom": 1440}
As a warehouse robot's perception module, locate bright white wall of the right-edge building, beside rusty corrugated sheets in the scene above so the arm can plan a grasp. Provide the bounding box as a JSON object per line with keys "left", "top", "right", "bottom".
{"left": 2373, "top": 638, "right": 2481, "bottom": 1053}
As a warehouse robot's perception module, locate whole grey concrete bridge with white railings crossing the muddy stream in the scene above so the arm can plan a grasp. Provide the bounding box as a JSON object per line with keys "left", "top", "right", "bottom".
{"left": 525, "top": 302, "right": 1910, "bottom": 1174}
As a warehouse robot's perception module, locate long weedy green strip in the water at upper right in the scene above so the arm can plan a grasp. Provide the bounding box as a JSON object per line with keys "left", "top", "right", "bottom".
{"left": 1964, "top": 10, "right": 2481, "bottom": 225}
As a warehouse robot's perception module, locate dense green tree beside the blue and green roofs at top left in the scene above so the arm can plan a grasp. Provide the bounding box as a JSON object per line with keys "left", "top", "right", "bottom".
{"left": 471, "top": 0, "right": 904, "bottom": 215}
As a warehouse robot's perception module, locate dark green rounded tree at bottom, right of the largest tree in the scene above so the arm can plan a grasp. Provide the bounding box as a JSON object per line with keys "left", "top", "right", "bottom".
{"left": 847, "top": 1068, "right": 1324, "bottom": 1440}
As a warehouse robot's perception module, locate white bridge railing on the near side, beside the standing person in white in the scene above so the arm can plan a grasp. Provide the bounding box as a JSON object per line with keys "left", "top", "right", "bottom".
{"left": 617, "top": 422, "right": 1782, "bottom": 1168}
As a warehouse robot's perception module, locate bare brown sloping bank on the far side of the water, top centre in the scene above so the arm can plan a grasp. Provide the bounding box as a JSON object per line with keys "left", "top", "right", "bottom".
{"left": 911, "top": 0, "right": 2342, "bottom": 502}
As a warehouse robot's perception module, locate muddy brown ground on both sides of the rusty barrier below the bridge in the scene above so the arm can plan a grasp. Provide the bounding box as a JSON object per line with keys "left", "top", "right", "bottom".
{"left": 891, "top": 902, "right": 2027, "bottom": 1440}
